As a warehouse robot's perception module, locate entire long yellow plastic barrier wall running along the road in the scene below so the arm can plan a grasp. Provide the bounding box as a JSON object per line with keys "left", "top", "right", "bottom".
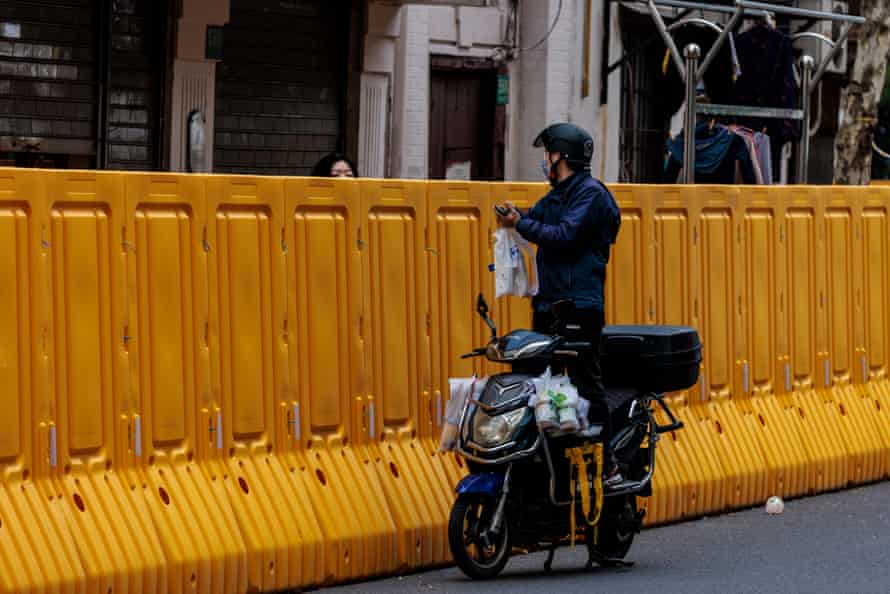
{"left": 0, "top": 164, "right": 890, "bottom": 593}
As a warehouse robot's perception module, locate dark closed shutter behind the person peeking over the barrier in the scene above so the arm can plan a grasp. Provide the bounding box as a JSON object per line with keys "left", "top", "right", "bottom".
{"left": 214, "top": 0, "right": 349, "bottom": 175}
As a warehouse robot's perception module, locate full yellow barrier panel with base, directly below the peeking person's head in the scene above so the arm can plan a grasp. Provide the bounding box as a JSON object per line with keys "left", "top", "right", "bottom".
{"left": 285, "top": 179, "right": 396, "bottom": 581}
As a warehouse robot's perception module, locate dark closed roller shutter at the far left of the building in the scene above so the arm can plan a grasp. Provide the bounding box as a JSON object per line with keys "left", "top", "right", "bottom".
{"left": 0, "top": 0, "right": 97, "bottom": 167}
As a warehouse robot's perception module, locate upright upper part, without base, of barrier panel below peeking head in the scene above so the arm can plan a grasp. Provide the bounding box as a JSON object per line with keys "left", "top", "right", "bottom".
{"left": 285, "top": 180, "right": 365, "bottom": 439}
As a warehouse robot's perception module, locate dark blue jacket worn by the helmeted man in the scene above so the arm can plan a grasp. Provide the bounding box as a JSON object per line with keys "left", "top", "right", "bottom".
{"left": 516, "top": 173, "right": 621, "bottom": 311}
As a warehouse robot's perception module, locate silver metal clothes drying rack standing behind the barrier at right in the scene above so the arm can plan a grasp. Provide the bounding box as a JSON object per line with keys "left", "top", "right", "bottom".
{"left": 645, "top": 0, "right": 865, "bottom": 184}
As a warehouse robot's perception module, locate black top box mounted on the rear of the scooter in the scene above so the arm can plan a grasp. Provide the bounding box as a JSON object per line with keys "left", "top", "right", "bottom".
{"left": 600, "top": 326, "right": 702, "bottom": 394}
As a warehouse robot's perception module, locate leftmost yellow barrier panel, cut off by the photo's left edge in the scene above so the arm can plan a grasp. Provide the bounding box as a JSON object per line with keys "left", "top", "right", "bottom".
{"left": 0, "top": 169, "right": 87, "bottom": 594}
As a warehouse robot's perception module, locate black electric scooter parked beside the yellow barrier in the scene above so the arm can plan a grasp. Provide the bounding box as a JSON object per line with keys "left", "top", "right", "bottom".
{"left": 448, "top": 295, "right": 701, "bottom": 579}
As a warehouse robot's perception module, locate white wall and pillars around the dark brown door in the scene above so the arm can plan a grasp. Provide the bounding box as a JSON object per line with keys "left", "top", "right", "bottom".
{"left": 359, "top": 0, "right": 620, "bottom": 180}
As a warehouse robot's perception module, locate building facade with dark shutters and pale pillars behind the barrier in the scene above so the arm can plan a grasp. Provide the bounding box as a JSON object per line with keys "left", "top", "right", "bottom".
{"left": 0, "top": 0, "right": 855, "bottom": 182}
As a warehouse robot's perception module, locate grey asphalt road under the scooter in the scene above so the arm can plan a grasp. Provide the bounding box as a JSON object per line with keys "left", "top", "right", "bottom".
{"left": 322, "top": 482, "right": 890, "bottom": 594}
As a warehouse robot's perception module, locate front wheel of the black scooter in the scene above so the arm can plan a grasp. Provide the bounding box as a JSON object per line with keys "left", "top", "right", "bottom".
{"left": 448, "top": 497, "right": 510, "bottom": 580}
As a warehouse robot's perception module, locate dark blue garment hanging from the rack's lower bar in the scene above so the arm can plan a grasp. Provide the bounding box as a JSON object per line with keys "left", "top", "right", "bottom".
{"left": 665, "top": 122, "right": 757, "bottom": 184}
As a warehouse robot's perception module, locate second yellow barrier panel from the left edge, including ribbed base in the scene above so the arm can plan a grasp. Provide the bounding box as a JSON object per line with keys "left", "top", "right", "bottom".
{"left": 47, "top": 172, "right": 164, "bottom": 592}
